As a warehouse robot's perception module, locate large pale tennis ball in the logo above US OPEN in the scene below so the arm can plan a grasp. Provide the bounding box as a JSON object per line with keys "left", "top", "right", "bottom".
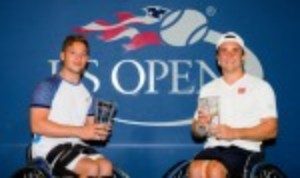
{"left": 160, "top": 9, "right": 207, "bottom": 47}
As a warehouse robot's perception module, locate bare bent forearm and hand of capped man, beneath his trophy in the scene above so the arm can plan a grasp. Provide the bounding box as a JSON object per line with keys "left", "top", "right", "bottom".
{"left": 210, "top": 117, "right": 278, "bottom": 141}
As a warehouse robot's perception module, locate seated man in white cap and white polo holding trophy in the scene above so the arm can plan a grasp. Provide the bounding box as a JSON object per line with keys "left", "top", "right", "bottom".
{"left": 187, "top": 32, "right": 277, "bottom": 178}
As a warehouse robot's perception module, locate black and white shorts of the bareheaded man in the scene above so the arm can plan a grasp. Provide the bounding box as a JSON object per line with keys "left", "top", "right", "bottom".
{"left": 46, "top": 143, "right": 103, "bottom": 174}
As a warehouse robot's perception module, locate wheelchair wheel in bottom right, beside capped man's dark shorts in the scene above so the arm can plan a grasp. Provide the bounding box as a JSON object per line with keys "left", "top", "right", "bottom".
{"left": 250, "top": 162, "right": 287, "bottom": 178}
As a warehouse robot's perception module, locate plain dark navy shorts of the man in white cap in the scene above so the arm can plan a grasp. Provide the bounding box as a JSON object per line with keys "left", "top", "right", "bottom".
{"left": 194, "top": 146, "right": 259, "bottom": 178}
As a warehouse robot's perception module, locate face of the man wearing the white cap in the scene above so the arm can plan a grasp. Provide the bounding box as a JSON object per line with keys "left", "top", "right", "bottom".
{"left": 217, "top": 42, "right": 243, "bottom": 73}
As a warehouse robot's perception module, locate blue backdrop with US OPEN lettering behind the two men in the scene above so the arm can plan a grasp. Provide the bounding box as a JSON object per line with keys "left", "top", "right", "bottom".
{"left": 0, "top": 0, "right": 300, "bottom": 178}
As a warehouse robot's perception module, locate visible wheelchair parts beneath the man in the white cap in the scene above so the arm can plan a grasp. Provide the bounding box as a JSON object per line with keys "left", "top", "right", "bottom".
{"left": 163, "top": 153, "right": 287, "bottom": 178}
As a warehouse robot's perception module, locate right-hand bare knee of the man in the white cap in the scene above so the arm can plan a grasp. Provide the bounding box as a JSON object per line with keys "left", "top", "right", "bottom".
{"left": 207, "top": 160, "right": 227, "bottom": 178}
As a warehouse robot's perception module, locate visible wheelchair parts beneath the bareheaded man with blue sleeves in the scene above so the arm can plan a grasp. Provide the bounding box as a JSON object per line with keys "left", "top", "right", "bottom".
{"left": 11, "top": 146, "right": 129, "bottom": 178}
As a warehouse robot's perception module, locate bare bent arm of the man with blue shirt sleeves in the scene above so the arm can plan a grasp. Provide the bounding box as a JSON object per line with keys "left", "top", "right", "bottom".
{"left": 30, "top": 107, "right": 110, "bottom": 140}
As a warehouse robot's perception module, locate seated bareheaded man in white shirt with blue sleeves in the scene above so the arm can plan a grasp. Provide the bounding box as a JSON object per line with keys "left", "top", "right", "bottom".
{"left": 30, "top": 35, "right": 113, "bottom": 177}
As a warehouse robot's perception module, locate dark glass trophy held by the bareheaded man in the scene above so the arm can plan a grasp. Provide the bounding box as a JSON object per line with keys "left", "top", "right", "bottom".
{"left": 95, "top": 100, "right": 116, "bottom": 124}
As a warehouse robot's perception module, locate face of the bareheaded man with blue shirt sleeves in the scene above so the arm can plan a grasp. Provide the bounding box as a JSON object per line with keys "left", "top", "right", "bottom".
{"left": 60, "top": 42, "right": 88, "bottom": 74}
